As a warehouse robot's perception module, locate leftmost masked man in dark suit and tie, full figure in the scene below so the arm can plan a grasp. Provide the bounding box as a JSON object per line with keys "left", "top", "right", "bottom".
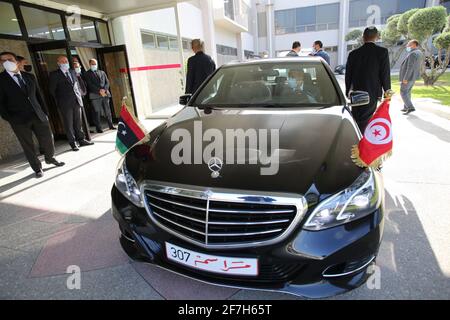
{"left": 0, "top": 52, "right": 64, "bottom": 178}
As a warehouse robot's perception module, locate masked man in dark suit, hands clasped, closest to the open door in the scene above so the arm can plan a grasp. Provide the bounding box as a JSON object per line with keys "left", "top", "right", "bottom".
{"left": 84, "top": 59, "right": 116, "bottom": 133}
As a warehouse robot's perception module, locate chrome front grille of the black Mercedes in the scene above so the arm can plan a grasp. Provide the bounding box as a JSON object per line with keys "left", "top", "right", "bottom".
{"left": 142, "top": 182, "right": 307, "bottom": 248}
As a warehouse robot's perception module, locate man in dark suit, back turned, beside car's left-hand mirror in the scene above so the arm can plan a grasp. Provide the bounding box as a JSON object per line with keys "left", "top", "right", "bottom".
{"left": 186, "top": 39, "right": 216, "bottom": 94}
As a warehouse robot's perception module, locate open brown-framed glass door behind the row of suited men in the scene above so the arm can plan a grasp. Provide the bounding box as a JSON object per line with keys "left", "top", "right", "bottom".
{"left": 97, "top": 45, "right": 137, "bottom": 120}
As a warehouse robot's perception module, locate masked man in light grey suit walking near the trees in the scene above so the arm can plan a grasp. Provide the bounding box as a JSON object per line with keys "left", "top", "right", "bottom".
{"left": 400, "top": 40, "right": 423, "bottom": 115}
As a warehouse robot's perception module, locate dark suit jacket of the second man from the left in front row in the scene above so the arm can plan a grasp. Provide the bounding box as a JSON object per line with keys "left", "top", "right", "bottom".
{"left": 49, "top": 69, "right": 83, "bottom": 109}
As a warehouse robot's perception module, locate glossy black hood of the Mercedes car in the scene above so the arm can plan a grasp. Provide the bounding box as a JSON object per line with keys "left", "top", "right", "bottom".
{"left": 127, "top": 106, "right": 361, "bottom": 194}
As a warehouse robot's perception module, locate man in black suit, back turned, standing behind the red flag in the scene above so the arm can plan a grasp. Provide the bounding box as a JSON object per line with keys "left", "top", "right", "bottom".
{"left": 345, "top": 27, "right": 391, "bottom": 133}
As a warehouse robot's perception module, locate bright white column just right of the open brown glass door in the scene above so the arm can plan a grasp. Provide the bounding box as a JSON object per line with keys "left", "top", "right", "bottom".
{"left": 111, "top": 16, "right": 152, "bottom": 119}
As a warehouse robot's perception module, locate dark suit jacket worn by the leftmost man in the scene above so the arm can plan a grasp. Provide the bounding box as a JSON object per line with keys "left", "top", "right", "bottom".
{"left": 0, "top": 71, "right": 48, "bottom": 124}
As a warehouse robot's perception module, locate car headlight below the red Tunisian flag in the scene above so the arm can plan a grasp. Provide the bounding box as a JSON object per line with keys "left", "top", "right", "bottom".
{"left": 304, "top": 170, "right": 381, "bottom": 231}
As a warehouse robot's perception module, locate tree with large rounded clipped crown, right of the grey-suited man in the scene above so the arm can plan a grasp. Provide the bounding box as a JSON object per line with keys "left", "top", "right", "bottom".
{"left": 407, "top": 6, "right": 450, "bottom": 85}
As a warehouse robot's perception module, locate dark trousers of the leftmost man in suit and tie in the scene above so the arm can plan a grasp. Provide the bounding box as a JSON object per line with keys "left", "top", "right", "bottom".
{"left": 11, "top": 117, "right": 55, "bottom": 172}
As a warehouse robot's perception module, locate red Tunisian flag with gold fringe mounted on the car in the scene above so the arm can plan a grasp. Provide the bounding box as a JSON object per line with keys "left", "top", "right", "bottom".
{"left": 352, "top": 95, "right": 393, "bottom": 168}
